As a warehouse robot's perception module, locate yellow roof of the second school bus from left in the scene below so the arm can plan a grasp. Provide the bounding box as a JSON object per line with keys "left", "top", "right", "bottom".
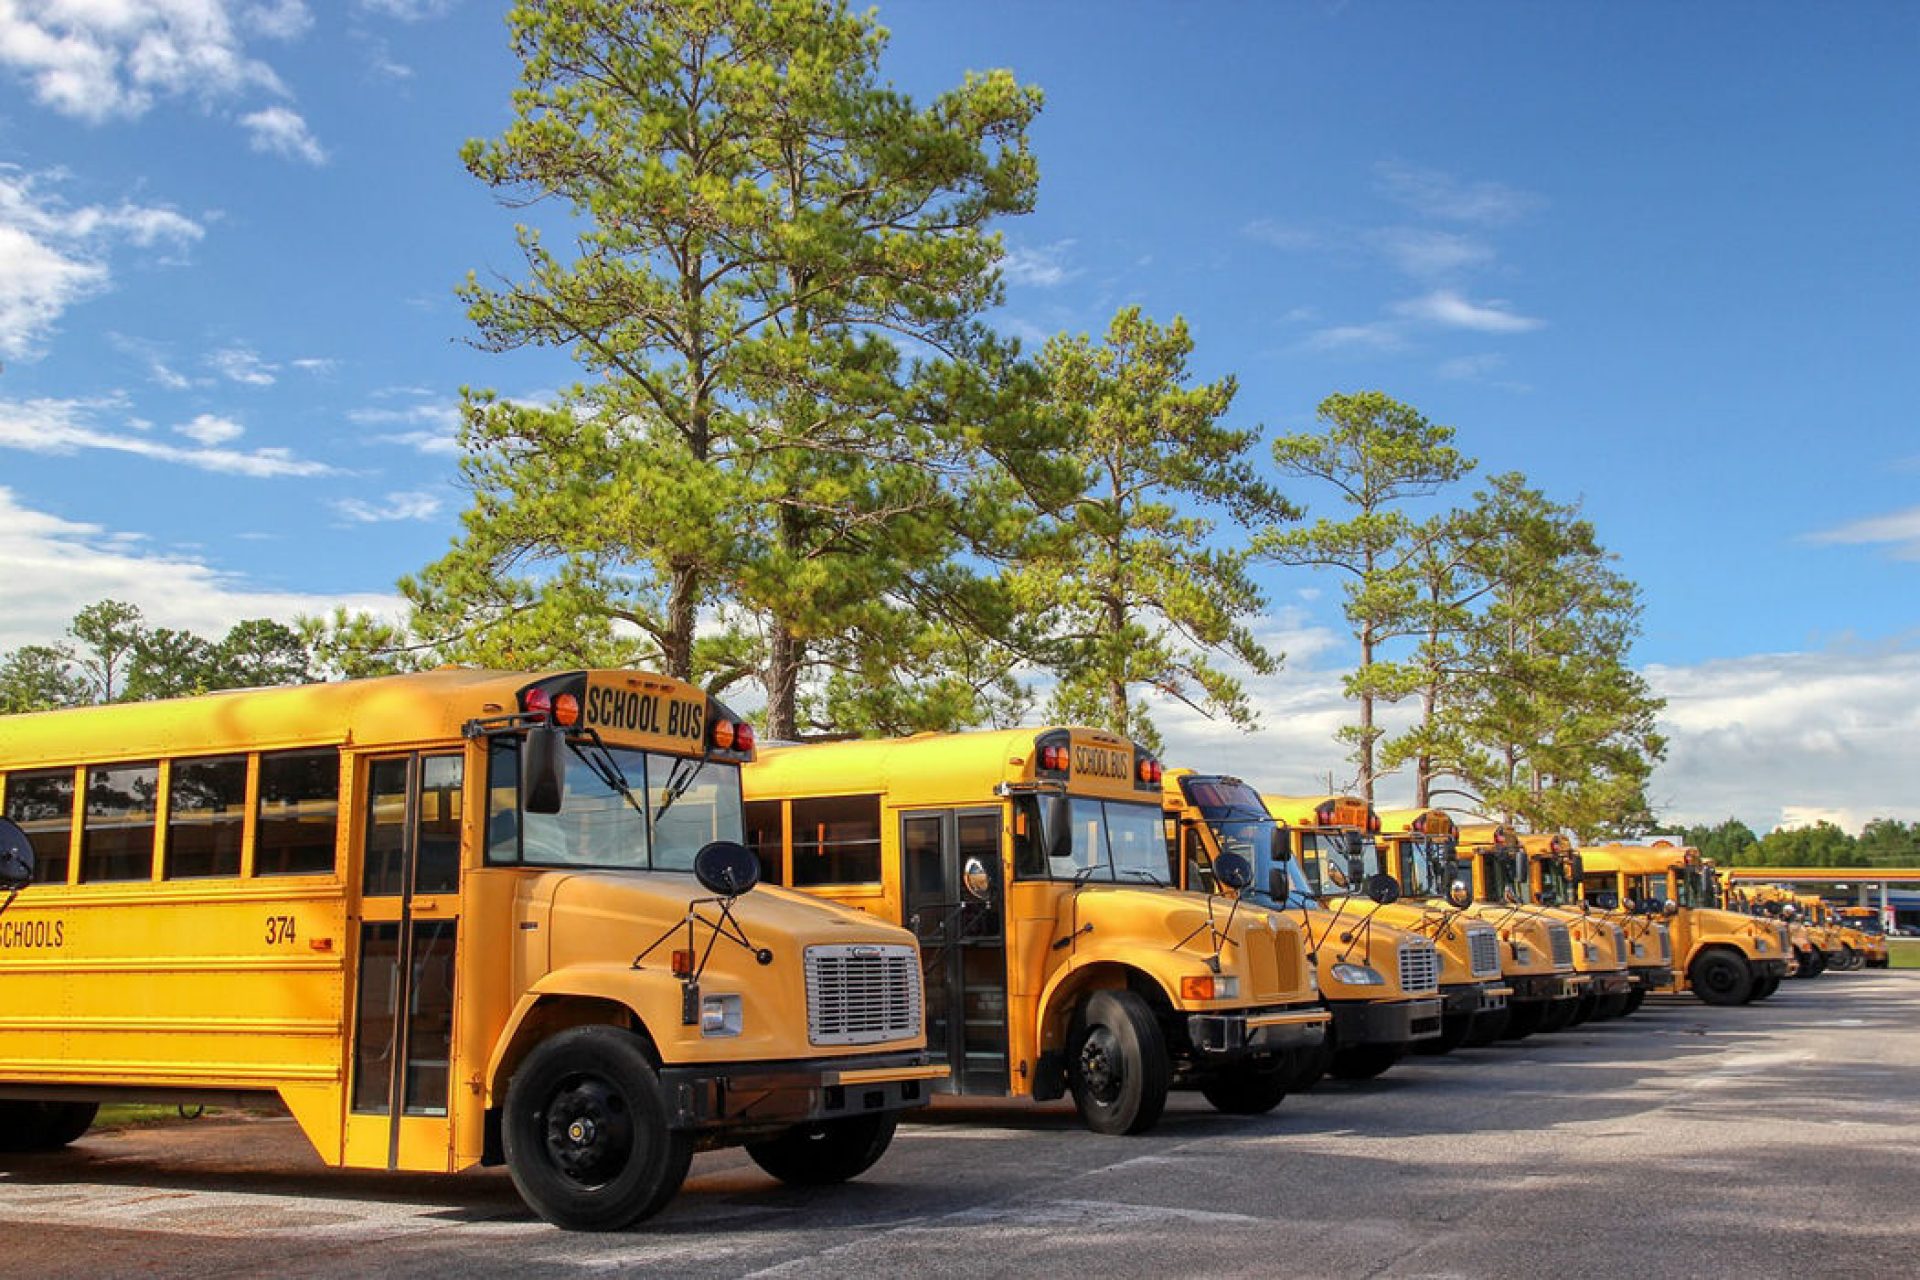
{"left": 745, "top": 725, "right": 1136, "bottom": 806}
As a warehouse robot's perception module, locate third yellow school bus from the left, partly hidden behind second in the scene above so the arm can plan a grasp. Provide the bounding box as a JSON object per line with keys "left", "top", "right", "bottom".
{"left": 1162, "top": 782, "right": 1440, "bottom": 1088}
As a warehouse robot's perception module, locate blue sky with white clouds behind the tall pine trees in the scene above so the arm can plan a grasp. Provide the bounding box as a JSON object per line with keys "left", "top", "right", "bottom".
{"left": 0, "top": 0, "right": 1920, "bottom": 827}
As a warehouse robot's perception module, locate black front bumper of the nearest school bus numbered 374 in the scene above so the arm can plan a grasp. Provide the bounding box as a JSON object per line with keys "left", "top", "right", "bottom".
{"left": 660, "top": 1050, "right": 947, "bottom": 1132}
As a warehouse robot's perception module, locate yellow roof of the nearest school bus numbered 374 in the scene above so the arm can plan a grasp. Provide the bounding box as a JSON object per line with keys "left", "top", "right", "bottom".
{"left": 0, "top": 666, "right": 708, "bottom": 770}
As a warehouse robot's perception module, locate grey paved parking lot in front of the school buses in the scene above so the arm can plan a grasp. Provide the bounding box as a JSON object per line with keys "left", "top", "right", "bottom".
{"left": 0, "top": 973, "right": 1920, "bottom": 1280}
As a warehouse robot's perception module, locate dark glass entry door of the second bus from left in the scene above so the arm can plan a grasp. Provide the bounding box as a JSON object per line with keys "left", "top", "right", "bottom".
{"left": 900, "top": 808, "right": 1008, "bottom": 1094}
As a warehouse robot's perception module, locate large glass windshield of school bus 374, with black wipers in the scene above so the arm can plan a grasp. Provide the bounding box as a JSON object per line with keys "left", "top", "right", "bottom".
{"left": 488, "top": 737, "right": 743, "bottom": 871}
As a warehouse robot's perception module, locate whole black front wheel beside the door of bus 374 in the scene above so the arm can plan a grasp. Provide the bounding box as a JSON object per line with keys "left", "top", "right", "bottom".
{"left": 501, "top": 1027, "right": 693, "bottom": 1232}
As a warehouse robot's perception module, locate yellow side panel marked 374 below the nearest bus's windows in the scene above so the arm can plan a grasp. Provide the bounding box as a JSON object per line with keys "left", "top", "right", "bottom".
{"left": 0, "top": 879, "right": 349, "bottom": 1105}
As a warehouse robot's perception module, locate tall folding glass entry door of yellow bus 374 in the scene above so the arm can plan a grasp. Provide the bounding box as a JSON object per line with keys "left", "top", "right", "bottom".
{"left": 346, "top": 754, "right": 465, "bottom": 1171}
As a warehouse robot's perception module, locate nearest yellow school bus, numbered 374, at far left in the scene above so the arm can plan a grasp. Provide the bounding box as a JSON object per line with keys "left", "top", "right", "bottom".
{"left": 0, "top": 668, "right": 937, "bottom": 1230}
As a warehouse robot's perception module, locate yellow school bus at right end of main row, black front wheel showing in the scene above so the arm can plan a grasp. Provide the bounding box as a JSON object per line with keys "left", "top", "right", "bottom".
{"left": 1580, "top": 841, "right": 1791, "bottom": 1004}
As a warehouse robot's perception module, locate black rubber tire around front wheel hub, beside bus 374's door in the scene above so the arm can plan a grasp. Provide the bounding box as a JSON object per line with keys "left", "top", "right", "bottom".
{"left": 501, "top": 1025, "right": 693, "bottom": 1232}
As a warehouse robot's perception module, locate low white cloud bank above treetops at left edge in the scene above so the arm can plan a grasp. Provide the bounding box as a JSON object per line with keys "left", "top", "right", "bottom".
{"left": 0, "top": 486, "right": 405, "bottom": 651}
